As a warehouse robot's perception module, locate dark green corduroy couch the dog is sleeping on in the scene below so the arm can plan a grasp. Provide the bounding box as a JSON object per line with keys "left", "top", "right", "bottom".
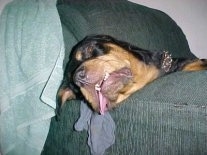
{"left": 42, "top": 0, "right": 207, "bottom": 155}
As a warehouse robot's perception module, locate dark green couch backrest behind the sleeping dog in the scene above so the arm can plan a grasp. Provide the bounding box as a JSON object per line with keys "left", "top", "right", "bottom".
{"left": 57, "top": 0, "right": 194, "bottom": 66}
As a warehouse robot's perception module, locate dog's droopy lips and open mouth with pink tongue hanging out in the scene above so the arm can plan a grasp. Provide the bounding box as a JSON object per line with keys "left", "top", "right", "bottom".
{"left": 77, "top": 67, "right": 132, "bottom": 114}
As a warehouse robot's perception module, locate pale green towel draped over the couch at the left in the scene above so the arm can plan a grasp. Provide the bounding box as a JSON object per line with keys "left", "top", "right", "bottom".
{"left": 0, "top": 0, "right": 64, "bottom": 155}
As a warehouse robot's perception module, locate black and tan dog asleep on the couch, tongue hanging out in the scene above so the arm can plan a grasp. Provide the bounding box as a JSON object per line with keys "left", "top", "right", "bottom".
{"left": 56, "top": 35, "right": 207, "bottom": 115}
